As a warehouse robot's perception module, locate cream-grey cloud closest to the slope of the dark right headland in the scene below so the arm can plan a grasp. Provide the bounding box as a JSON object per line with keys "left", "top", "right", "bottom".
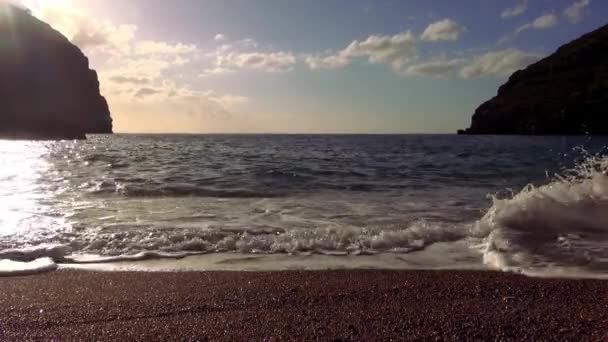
{"left": 460, "top": 49, "right": 542, "bottom": 79}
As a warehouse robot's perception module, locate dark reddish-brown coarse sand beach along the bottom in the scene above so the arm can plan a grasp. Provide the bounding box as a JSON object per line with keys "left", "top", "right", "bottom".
{"left": 0, "top": 271, "right": 608, "bottom": 341}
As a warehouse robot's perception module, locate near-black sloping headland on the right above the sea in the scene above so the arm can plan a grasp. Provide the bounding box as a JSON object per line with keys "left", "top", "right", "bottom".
{"left": 459, "top": 25, "right": 608, "bottom": 135}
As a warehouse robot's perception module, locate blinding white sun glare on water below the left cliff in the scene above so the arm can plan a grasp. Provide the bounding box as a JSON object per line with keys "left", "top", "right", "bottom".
{"left": 0, "top": 140, "right": 55, "bottom": 243}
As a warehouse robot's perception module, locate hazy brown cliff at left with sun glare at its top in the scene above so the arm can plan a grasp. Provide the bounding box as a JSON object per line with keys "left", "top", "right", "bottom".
{"left": 0, "top": 2, "right": 112, "bottom": 139}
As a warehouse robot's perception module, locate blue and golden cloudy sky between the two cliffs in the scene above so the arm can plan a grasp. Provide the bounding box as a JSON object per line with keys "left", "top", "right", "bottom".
{"left": 15, "top": 0, "right": 608, "bottom": 133}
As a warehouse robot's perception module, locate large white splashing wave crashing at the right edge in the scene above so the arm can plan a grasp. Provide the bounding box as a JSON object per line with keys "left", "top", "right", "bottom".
{"left": 472, "top": 156, "right": 608, "bottom": 275}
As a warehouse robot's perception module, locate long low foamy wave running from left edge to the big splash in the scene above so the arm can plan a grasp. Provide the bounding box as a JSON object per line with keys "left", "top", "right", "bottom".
{"left": 0, "top": 220, "right": 467, "bottom": 273}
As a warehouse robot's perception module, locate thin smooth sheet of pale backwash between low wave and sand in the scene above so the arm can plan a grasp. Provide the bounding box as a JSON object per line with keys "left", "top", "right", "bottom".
{"left": 60, "top": 242, "right": 484, "bottom": 272}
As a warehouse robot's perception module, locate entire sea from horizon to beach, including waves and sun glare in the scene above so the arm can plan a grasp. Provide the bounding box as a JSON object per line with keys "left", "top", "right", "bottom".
{"left": 0, "top": 135, "right": 608, "bottom": 278}
